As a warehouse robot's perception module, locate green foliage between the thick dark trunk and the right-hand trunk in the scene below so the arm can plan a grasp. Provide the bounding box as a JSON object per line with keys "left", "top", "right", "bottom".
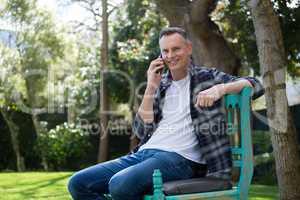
{"left": 215, "top": 0, "right": 259, "bottom": 74}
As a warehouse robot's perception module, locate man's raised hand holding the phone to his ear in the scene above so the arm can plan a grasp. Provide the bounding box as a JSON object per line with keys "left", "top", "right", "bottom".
{"left": 147, "top": 58, "right": 164, "bottom": 90}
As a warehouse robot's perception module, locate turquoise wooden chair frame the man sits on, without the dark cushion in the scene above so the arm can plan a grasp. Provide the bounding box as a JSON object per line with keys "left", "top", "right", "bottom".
{"left": 144, "top": 87, "right": 253, "bottom": 200}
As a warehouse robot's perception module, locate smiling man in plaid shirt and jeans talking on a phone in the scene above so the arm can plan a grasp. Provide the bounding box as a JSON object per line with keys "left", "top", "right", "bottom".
{"left": 69, "top": 27, "right": 263, "bottom": 200}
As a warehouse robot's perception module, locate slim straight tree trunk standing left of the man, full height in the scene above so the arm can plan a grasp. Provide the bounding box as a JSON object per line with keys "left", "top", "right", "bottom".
{"left": 98, "top": 0, "right": 109, "bottom": 162}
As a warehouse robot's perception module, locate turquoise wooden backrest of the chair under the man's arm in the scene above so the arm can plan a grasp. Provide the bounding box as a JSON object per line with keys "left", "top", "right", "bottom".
{"left": 225, "top": 87, "right": 253, "bottom": 199}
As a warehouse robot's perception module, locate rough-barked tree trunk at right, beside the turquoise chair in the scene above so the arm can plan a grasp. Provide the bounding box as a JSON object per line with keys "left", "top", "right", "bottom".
{"left": 248, "top": 0, "right": 300, "bottom": 200}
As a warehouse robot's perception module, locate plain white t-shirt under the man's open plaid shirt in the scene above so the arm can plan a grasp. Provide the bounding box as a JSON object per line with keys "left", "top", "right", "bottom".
{"left": 139, "top": 75, "right": 205, "bottom": 163}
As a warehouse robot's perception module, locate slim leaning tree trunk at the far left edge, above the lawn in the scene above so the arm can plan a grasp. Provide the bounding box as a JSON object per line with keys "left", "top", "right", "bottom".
{"left": 1, "top": 110, "right": 25, "bottom": 172}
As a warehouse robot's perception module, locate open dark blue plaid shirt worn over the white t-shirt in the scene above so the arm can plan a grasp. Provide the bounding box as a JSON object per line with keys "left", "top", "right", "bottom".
{"left": 133, "top": 65, "right": 264, "bottom": 179}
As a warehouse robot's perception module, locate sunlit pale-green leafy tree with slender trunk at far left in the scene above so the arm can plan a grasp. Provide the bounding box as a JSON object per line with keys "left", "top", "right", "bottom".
{"left": 3, "top": 0, "right": 64, "bottom": 170}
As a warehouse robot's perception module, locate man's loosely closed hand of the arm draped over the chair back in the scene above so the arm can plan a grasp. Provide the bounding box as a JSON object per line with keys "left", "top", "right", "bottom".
{"left": 195, "top": 84, "right": 225, "bottom": 107}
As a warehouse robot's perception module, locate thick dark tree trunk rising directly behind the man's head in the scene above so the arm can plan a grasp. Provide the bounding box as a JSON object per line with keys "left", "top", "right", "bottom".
{"left": 155, "top": 0, "right": 241, "bottom": 75}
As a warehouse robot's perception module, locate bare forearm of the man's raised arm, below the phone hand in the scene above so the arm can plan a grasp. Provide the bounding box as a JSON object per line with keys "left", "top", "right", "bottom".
{"left": 138, "top": 87, "right": 155, "bottom": 123}
